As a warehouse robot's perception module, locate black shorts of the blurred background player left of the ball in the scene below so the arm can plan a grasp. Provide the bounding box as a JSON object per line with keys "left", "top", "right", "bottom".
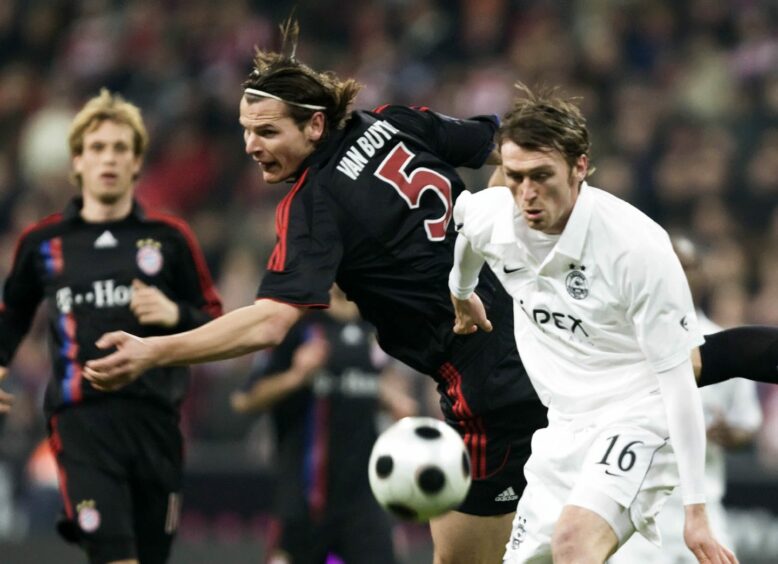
{"left": 266, "top": 492, "right": 396, "bottom": 564}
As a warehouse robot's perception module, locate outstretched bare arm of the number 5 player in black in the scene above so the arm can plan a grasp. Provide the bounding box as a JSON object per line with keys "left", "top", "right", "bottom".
{"left": 84, "top": 300, "right": 304, "bottom": 391}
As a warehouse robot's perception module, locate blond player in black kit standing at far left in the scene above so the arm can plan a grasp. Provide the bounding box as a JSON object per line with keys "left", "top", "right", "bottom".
{"left": 0, "top": 90, "right": 221, "bottom": 564}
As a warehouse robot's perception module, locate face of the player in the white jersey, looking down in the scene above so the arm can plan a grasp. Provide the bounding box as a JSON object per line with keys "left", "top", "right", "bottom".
{"left": 500, "top": 141, "right": 588, "bottom": 233}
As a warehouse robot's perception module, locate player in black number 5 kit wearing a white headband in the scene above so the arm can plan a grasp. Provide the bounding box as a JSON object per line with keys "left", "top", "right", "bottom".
{"left": 86, "top": 22, "right": 774, "bottom": 564}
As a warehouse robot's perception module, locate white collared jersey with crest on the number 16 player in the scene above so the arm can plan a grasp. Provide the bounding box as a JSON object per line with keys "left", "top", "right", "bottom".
{"left": 454, "top": 183, "right": 704, "bottom": 414}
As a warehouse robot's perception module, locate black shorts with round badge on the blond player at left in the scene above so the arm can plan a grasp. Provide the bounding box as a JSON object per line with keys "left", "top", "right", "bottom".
{"left": 49, "top": 396, "right": 183, "bottom": 564}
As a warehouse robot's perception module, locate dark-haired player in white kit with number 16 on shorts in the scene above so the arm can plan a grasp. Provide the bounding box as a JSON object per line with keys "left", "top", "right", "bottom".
{"left": 449, "top": 87, "right": 736, "bottom": 563}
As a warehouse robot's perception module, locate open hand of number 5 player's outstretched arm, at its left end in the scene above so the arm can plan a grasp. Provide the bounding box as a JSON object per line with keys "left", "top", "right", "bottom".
{"left": 84, "top": 331, "right": 157, "bottom": 392}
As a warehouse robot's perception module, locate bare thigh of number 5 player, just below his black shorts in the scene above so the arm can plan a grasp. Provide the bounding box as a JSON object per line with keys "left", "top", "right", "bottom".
{"left": 430, "top": 511, "right": 513, "bottom": 564}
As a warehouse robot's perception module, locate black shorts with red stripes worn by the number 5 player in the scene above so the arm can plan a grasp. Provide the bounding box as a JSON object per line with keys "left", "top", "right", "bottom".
{"left": 438, "top": 331, "right": 548, "bottom": 516}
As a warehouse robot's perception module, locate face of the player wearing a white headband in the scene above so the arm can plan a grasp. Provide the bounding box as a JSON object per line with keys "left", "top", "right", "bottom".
{"left": 240, "top": 97, "right": 324, "bottom": 184}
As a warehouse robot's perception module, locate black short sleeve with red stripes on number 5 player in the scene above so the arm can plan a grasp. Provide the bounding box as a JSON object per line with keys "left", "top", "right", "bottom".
{"left": 257, "top": 177, "right": 343, "bottom": 308}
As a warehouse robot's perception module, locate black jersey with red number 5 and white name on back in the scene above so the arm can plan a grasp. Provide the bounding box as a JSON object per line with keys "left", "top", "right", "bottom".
{"left": 258, "top": 106, "right": 511, "bottom": 374}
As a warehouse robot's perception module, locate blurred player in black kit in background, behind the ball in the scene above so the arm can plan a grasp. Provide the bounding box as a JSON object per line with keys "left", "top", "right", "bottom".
{"left": 232, "top": 287, "right": 414, "bottom": 564}
